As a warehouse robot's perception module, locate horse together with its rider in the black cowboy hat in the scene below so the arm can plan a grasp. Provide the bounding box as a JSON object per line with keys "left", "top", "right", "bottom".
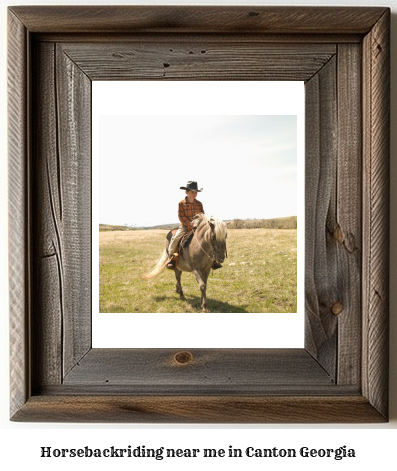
{"left": 142, "top": 181, "right": 227, "bottom": 311}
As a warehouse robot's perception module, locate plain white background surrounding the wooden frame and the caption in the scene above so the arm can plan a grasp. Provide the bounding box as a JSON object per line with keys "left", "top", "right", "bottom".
{"left": 0, "top": 0, "right": 397, "bottom": 470}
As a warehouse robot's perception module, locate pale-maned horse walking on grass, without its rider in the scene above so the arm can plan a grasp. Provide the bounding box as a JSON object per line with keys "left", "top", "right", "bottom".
{"left": 142, "top": 213, "right": 227, "bottom": 312}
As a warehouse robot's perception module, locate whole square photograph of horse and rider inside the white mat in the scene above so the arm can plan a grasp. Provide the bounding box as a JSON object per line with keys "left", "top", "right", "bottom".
{"left": 99, "top": 115, "right": 298, "bottom": 313}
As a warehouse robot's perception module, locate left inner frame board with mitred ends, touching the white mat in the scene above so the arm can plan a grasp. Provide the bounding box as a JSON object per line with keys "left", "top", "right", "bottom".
{"left": 56, "top": 47, "right": 92, "bottom": 375}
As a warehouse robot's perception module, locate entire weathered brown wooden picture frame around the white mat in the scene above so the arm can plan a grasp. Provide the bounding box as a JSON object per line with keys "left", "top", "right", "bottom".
{"left": 8, "top": 6, "right": 390, "bottom": 423}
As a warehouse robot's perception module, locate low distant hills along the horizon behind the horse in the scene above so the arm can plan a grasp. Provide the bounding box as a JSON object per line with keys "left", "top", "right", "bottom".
{"left": 99, "top": 216, "right": 298, "bottom": 232}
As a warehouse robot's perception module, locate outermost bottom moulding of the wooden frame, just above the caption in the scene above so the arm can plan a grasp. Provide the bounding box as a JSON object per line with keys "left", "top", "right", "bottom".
{"left": 14, "top": 394, "right": 385, "bottom": 424}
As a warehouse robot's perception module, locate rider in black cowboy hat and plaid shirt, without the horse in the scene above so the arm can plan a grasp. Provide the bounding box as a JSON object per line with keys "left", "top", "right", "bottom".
{"left": 167, "top": 181, "right": 222, "bottom": 270}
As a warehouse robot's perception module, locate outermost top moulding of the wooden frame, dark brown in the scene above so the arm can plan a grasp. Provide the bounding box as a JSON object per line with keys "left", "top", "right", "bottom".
{"left": 8, "top": 6, "right": 384, "bottom": 35}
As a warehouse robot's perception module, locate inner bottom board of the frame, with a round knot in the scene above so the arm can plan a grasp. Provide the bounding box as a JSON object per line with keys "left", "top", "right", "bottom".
{"left": 63, "top": 349, "right": 334, "bottom": 394}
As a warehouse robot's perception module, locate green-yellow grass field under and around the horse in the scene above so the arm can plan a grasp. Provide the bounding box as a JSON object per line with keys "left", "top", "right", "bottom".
{"left": 99, "top": 229, "right": 297, "bottom": 313}
